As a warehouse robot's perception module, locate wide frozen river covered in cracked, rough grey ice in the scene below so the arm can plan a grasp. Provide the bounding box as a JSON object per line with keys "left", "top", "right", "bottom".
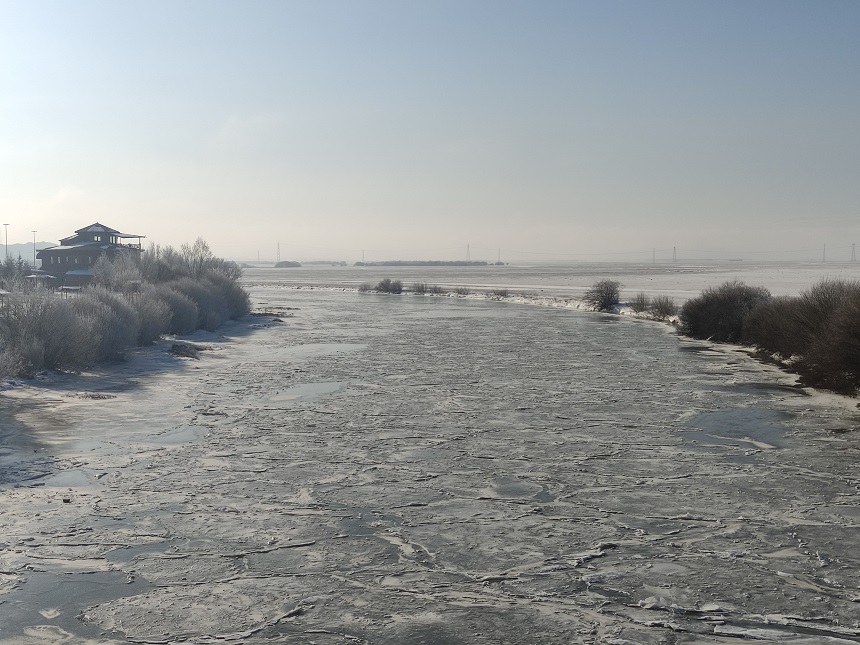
{"left": 0, "top": 267, "right": 860, "bottom": 645}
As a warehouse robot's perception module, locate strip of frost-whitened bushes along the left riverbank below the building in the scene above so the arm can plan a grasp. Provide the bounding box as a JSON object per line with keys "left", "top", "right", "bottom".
{"left": 0, "top": 239, "right": 250, "bottom": 378}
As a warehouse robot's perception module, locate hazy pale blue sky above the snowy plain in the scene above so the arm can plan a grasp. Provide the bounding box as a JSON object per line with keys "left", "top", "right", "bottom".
{"left": 0, "top": 0, "right": 860, "bottom": 261}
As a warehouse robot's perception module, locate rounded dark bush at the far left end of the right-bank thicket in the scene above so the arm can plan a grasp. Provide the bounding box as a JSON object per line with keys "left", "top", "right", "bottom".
{"left": 680, "top": 280, "right": 771, "bottom": 343}
